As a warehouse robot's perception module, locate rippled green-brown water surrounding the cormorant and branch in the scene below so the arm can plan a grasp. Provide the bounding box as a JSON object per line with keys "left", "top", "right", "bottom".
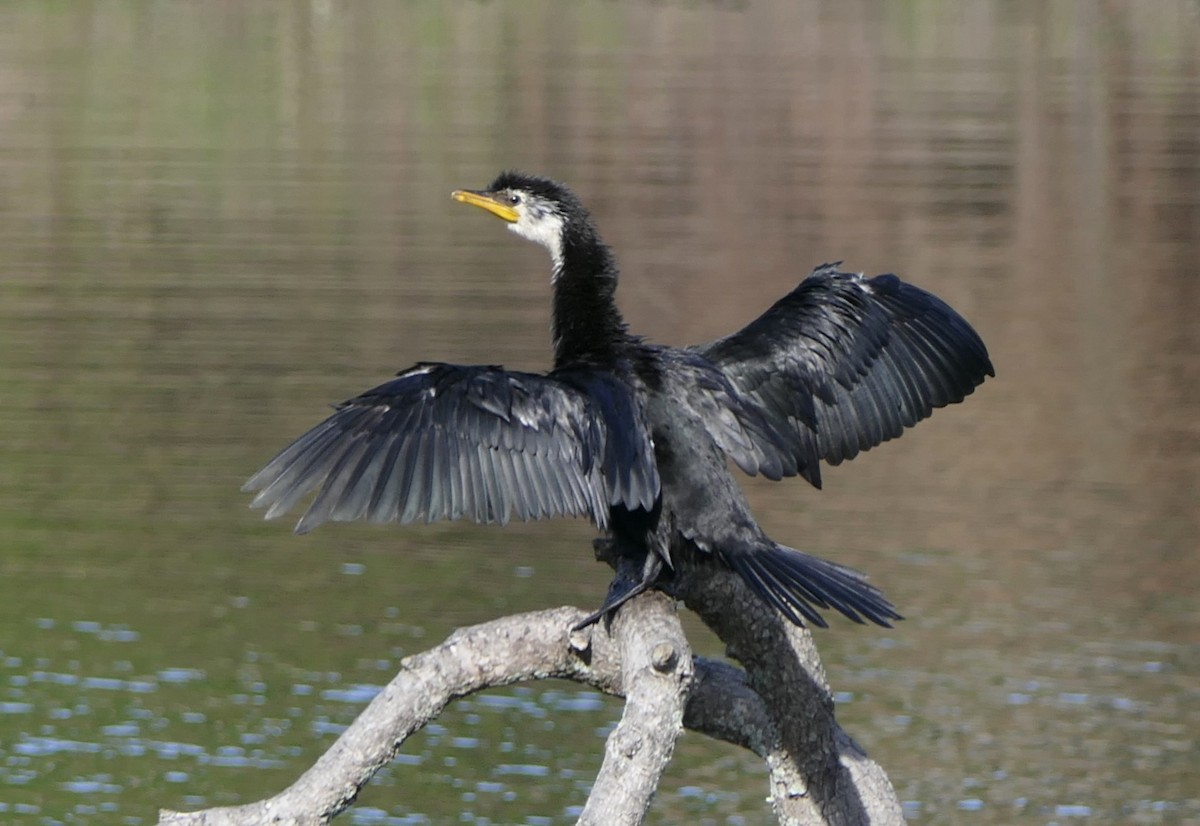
{"left": 0, "top": 0, "right": 1200, "bottom": 825}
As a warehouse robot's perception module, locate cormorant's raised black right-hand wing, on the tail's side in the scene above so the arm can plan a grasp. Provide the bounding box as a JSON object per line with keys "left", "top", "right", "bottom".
{"left": 691, "top": 264, "right": 995, "bottom": 487}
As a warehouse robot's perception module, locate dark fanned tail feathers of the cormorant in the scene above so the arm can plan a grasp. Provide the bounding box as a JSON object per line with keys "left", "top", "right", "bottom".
{"left": 721, "top": 539, "right": 904, "bottom": 628}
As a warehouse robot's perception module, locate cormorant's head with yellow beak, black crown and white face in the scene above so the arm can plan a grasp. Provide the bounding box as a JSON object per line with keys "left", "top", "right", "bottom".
{"left": 454, "top": 172, "right": 595, "bottom": 274}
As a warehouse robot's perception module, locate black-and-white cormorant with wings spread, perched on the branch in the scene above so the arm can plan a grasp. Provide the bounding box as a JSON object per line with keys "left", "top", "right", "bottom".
{"left": 244, "top": 170, "right": 995, "bottom": 628}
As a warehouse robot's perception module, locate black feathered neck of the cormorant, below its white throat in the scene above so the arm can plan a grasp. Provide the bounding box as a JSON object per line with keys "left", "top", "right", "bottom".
{"left": 553, "top": 227, "right": 630, "bottom": 367}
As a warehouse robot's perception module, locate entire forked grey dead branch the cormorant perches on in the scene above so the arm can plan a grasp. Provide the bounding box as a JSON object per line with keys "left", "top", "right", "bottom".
{"left": 158, "top": 568, "right": 904, "bottom": 826}
